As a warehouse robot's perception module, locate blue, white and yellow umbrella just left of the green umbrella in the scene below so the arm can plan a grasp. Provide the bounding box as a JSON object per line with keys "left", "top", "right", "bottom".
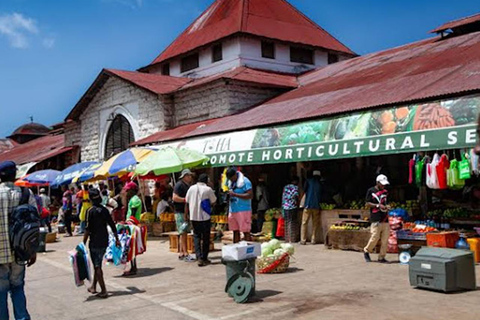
{"left": 95, "top": 148, "right": 155, "bottom": 179}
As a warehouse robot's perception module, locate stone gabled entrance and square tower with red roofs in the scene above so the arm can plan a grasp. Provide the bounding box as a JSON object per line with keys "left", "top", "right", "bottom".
{"left": 65, "top": 0, "right": 356, "bottom": 161}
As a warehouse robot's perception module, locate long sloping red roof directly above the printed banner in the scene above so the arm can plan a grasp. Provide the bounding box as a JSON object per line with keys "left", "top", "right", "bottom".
{"left": 136, "top": 32, "right": 480, "bottom": 144}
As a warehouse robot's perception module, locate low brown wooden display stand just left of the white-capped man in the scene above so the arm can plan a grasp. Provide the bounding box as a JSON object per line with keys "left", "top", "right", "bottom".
{"left": 326, "top": 229, "right": 370, "bottom": 251}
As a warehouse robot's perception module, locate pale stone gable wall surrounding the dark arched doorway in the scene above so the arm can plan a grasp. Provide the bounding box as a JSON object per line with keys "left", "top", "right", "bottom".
{"left": 71, "top": 77, "right": 172, "bottom": 161}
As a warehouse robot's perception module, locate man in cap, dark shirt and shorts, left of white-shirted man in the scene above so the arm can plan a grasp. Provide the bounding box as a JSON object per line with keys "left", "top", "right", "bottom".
{"left": 173, "top": 169, "right": 195, "bottom": 262}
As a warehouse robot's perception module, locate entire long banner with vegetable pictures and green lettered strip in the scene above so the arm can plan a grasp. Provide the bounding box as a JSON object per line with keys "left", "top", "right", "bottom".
{"left": 164, "top": 95, "right": 480, "bottom": 167}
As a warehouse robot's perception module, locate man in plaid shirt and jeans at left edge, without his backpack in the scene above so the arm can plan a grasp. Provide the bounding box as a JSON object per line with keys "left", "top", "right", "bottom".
{"left": 0, "top": 161, "right": 37, "bottom": 319}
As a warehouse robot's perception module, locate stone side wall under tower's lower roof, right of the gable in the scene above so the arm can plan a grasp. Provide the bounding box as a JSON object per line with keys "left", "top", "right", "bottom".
{"left": 173, "top": 80, "right": 285, "bottom": 126}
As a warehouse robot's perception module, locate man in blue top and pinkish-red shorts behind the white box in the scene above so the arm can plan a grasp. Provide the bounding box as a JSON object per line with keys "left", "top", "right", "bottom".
{"left": 227, "top": 167, "right": 253, "bottom": 243}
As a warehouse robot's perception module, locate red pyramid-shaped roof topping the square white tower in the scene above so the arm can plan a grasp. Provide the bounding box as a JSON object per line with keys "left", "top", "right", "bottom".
{"left": 148, "top": 0, "right": 355, "bottom": 64}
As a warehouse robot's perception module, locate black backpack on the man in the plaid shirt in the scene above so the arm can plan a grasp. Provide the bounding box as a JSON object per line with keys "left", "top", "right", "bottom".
{"left": 9, "top": 189, "right": 41, "bottom": 264}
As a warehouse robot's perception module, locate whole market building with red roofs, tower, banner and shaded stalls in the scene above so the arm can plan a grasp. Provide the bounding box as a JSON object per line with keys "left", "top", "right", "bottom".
{"left": 59, "top": 0, "right": 480, "bottom": 248}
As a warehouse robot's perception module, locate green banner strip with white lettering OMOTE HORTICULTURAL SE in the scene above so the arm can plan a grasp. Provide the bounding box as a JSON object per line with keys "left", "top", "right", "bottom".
{"left": 210, "top": 125, "right": 476, "bottom": 167}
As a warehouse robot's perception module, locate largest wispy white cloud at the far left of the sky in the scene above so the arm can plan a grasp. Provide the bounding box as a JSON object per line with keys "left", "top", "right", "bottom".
{"left": 0, "top": 12, "right": 39, "bottom": 49}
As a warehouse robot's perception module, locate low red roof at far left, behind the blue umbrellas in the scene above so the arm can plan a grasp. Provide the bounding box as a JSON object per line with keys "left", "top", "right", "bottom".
{"left": 0, "top": 134, "right": 72, "bottom": 164}
